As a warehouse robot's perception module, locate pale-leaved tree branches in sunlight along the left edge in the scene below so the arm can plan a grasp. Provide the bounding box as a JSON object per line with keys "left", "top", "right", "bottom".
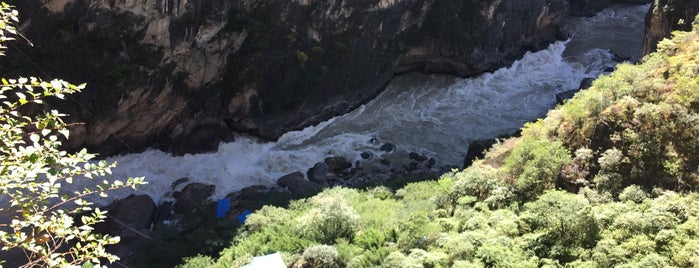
{"left": 0, "top": 2, "right": 144, "bottom": 267}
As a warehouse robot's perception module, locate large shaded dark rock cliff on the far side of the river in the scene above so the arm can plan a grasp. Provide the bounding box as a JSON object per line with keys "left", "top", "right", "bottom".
{"left": 8, "top": 0, "right": 568, "bottom": 154}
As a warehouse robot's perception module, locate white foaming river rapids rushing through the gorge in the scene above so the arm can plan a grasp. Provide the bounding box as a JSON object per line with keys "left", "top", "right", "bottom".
{"left": 93, "top": 5, "right": 649, "bottom": 202}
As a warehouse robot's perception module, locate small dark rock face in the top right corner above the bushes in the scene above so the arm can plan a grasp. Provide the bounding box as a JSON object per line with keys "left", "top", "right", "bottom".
{"left": 643, "top": 0, "right": 699, "bottom": 55}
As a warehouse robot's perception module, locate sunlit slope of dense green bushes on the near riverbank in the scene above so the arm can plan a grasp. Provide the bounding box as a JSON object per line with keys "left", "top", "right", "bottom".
{"left": 180, "top": 15, "right": 699, "bottom": 267}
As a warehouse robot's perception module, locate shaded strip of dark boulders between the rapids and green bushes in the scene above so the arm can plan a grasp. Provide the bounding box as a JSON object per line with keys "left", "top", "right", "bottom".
{"left": 97, "top": 140, "right": 448, "bottom": 260}
